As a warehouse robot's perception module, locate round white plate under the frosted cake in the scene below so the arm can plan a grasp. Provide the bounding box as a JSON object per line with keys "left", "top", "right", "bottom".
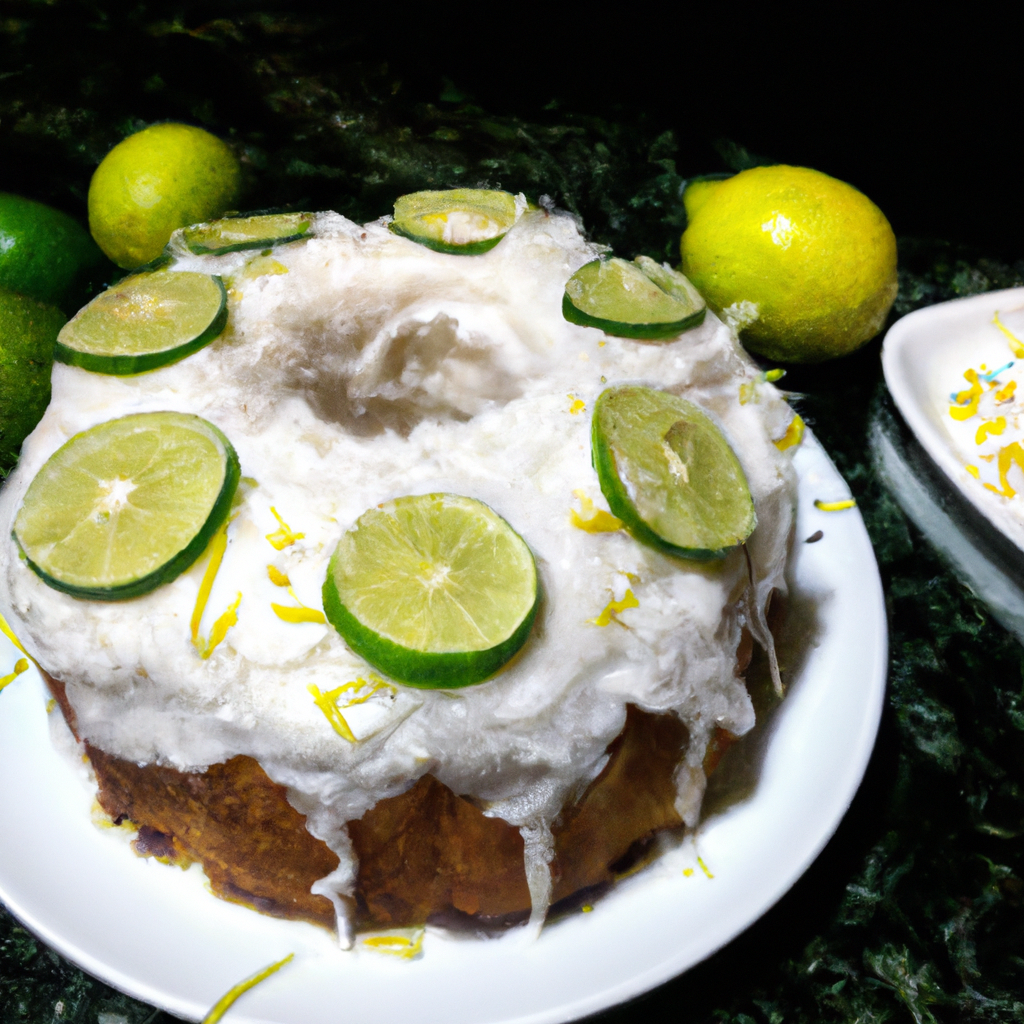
{"left": 0, "top": 435, "right": 887, "bottom": 1024}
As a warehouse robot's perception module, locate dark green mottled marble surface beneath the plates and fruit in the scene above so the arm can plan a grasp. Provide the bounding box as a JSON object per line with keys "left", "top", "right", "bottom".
{"left": 0, "top": 0, "right": 1024, "bottom": 1024}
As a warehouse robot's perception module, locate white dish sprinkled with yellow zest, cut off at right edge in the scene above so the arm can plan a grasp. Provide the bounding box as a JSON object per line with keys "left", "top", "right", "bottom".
{"left": 882, "top": 288, "right": 1024, "bottom": 549}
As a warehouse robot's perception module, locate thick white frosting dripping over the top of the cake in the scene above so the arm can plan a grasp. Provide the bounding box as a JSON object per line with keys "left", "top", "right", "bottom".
{"left": 0, "top": 210, "right": 794, "bottom": 929}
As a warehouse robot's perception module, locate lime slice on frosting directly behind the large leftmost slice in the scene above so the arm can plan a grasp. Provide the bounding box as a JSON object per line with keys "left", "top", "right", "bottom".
{"left": 53, "top": 270, "right": 227, "bottom": 376}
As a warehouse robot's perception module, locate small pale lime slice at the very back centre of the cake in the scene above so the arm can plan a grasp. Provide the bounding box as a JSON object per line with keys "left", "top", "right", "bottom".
{"left": 391, "top": 188, "right": 518, "bottom": 256}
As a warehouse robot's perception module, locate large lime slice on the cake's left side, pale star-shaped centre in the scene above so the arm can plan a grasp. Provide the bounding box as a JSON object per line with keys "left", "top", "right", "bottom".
{"left": 13, "top": 413, "right": 239, "bottom": 601}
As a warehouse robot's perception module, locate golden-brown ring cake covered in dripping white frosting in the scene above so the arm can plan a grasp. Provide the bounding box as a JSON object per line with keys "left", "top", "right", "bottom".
{"left": 0, "top": 193, "right": 799, "bottom": 940}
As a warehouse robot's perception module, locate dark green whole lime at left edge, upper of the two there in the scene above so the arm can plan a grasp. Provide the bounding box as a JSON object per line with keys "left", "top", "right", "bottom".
{"left": 0, "top": 193, "right": 113, "bottom": 306}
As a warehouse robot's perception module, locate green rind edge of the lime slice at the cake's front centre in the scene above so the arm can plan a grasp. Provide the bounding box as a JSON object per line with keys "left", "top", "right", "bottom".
{"left": 323, "top": 553, "right": 541, "bottom": 690}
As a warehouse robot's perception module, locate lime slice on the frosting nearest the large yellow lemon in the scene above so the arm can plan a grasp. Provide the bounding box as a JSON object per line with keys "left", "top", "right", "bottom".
{"left": 562, "top": 256, "right": 707, "bottom": 341}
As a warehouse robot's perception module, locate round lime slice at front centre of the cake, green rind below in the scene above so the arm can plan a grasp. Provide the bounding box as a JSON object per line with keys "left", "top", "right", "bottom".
{"left": 324, "top": 495, "right": 538, "bottom": 688}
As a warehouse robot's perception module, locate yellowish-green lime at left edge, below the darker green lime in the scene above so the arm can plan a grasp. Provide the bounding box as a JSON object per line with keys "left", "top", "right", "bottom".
{"left": 0, "top": 290, "right": 67, "bottom": 470}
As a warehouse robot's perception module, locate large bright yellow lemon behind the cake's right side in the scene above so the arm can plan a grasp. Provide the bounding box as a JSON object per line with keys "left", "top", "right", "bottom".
{"left": 680, "top": 165, "right": 896, "bottom": 362}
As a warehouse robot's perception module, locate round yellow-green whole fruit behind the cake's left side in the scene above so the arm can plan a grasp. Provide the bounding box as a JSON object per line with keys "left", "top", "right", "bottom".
{"left": 89, "top": 124, "right": 241, "bottom": 269}
